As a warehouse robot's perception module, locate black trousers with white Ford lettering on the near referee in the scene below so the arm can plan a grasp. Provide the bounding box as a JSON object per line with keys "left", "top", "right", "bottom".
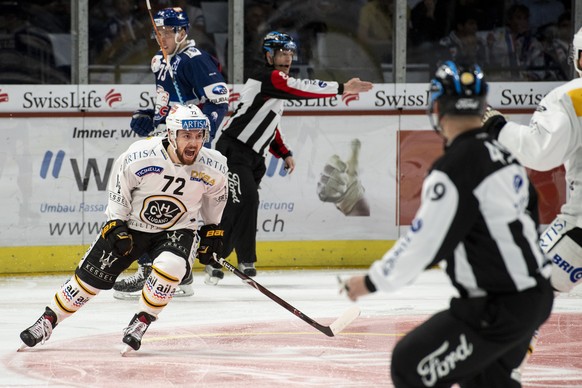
{"left": 390, "top": 279, "right": 554, "bottom": 388}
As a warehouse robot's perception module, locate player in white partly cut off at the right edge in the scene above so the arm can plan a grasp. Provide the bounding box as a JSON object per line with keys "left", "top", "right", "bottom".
{"left": 483, "top": 28, "right": 582, "bottom": 292}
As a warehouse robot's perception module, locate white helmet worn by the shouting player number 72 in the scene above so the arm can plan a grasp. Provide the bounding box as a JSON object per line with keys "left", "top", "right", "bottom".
{"left": 166, "top": 104, "right": 210, "bottom": 148}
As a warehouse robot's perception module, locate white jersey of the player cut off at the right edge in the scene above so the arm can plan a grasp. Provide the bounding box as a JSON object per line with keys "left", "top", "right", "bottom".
{"left": 499, "top": 78, "right": 582, "bottom": 227}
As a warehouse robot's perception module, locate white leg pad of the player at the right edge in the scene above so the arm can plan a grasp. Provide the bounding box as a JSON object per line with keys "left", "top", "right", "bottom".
{"left": 540, "top": 219, "right": 582, "bottom": 292}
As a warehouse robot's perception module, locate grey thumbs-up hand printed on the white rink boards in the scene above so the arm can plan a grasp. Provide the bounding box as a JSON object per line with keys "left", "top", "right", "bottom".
{"left": 317, "top": 139, "right": 365, "bottom": 215}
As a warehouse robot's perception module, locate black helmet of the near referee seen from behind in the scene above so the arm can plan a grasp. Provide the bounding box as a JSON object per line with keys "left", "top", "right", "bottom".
{"left": 429, "top": 61, "right": 488, "bottom": 118}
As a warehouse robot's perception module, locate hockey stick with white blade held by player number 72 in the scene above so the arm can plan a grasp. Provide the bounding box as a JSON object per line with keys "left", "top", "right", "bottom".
{"left": 214, "top": 255, "right": 360, "bottom": 337}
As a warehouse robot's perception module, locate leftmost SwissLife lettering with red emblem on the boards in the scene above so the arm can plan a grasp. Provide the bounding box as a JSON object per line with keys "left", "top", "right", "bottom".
{"left": 22, "top": 88, "right": 123, "bottom": 110}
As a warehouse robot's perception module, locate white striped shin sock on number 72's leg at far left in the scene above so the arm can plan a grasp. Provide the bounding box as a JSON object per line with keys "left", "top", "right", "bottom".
{"left": 50, "top": 275, "right": 101, "bottom": 322}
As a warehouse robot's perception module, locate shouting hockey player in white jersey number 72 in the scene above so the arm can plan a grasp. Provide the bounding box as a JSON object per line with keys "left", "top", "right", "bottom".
{"left": 20, "top": 104, "right": 228, "bottom": 352}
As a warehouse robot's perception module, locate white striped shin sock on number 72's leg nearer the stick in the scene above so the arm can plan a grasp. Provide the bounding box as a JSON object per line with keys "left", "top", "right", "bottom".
{"left": 139, "top": 251, "right": 187, "bottom": 317}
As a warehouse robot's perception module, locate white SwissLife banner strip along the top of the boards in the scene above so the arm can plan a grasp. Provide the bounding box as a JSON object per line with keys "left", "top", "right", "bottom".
{"left": 0, "top": 82, "right": 559, "bottom": 114}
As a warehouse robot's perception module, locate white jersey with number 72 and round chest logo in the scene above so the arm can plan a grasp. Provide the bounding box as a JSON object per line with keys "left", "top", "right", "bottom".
{"left": 105, "top": 137, "right": 228, "bottom": 233}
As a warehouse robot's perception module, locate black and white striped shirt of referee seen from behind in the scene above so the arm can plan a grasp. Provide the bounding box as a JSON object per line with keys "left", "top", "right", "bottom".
{"left": 368, "top": 129, "right": 547, "bottom": 297}
